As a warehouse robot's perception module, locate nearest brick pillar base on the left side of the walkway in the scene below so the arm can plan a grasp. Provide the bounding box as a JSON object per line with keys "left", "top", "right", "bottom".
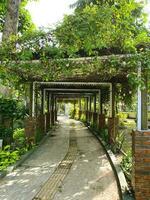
{"left": 25, "top": 117, "right": 36, "bottom": 143}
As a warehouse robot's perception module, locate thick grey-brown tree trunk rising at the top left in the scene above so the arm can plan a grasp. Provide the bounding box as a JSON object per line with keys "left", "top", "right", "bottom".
{"left": 2, "top": 0, "right": 21, "bottom": 41}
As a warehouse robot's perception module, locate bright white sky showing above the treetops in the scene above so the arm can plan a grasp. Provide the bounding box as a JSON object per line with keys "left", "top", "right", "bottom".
{"left": 27, "top": 0, "right": 150, "bottom": 27}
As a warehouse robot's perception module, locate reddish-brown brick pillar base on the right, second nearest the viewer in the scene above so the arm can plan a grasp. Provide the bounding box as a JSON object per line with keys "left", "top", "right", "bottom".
{"left": 108, "top": 117, "right": 119, "bottom": 143}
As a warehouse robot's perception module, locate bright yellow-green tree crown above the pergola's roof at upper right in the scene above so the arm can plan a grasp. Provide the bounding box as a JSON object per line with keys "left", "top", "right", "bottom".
{"left": 55, "top": 0, "right": 150, "bottom": 56}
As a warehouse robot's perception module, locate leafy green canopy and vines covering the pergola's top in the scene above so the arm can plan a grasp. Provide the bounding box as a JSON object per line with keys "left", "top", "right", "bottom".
{"left": 0, "top": 0, "right": 150, "bottom": 112}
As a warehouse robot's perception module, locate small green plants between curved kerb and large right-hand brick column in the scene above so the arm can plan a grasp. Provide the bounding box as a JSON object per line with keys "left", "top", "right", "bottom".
{"left": 121, "top": 151, "right": 132, "bottom": 180}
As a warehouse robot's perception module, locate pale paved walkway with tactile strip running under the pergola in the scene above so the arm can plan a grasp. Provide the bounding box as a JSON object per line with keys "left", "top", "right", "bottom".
{"left": 0, "top": 117, "right": 119, "bottom": 200}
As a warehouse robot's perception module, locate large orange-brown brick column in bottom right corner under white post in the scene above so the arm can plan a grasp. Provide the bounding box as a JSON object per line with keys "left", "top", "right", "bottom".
{"left": 132, "top": 131, "right": 150, "bottom": 200}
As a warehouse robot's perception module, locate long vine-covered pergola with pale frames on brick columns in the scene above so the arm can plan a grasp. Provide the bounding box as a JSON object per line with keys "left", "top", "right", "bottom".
{"left": 3, "top": 55, "right": 150, "bottom": 200}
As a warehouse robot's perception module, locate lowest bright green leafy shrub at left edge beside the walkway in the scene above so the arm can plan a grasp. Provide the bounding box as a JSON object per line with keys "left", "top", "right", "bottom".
{"left": 0, "top": 145, "right": 20, "bottom": 170}
